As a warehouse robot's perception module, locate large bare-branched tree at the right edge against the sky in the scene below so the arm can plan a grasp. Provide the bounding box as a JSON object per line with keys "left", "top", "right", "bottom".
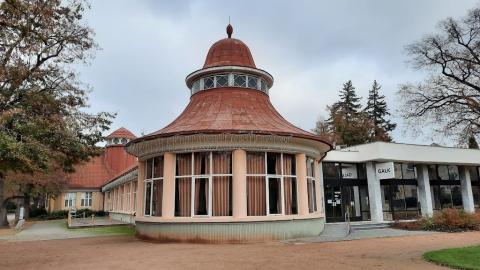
{"left": 399, "top": 8, "right": 480, "bottom": 141}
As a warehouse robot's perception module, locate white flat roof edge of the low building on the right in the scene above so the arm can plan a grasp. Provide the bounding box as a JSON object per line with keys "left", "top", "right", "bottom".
{"left": 324, "top": 142, "right": 480, "bottom": 166}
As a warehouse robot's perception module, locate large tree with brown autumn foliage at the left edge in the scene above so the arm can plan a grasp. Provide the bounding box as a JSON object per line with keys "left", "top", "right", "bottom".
{"left": 0, "top": 0, "right": 112, "bottom": 226}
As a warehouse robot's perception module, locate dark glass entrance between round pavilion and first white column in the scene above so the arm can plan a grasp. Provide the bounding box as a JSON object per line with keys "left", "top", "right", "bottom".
{"left": 325, "top": 185, "right": 370, "bottom": 222}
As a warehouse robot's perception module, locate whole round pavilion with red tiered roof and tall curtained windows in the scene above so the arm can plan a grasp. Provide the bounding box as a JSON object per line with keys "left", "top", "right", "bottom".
{"left": 126, "top": 25, "right": 332, "bottom": 242}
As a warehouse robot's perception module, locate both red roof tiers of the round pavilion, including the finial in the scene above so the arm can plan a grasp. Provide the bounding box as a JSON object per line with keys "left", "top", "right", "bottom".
{"left": 127, "top": 28, "right": 331, "bottom": 147}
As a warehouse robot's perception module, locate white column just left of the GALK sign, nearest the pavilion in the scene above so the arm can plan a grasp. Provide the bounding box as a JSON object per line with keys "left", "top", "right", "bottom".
{"left": 366, "top": 162, "right": 383, "bottom": 222}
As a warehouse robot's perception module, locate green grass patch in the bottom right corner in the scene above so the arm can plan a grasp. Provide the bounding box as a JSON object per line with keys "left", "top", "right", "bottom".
{"left": 423, "top": 246, "right": 480, "bottom": 270}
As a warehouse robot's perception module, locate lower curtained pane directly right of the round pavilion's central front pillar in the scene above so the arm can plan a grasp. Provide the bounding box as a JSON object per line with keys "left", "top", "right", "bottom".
{"left": 247, "top": 176, "right": 267, "bottom": 216}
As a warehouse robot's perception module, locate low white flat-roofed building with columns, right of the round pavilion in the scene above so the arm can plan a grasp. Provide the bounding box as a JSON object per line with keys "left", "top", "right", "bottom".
{"left": 321, "top": 142, "right": 480, "bottom": 222}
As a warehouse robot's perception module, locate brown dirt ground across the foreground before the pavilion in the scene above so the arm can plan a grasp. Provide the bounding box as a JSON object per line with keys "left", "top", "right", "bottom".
{"left": 0, "top": 232, "right": 480, "bottom": 270}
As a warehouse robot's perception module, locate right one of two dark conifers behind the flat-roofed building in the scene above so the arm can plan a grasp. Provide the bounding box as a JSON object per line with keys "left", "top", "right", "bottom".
{"left": 364, "top": 80, "right": 397, "bottom": 142}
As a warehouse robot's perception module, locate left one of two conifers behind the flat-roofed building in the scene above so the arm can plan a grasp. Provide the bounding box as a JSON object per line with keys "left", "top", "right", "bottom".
{"left": 327, "top": 80, "right": 371, "bottom": 146}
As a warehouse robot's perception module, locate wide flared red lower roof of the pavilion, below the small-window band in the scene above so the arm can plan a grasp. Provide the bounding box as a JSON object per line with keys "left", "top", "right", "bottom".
{"left": 142, "top": 87, "right": 323, "bottom": 141}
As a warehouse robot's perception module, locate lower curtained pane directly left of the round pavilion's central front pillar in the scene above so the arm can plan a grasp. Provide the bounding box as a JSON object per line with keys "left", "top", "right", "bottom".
{"left": 212, "top": 176, "right": 232, "bottom": 216}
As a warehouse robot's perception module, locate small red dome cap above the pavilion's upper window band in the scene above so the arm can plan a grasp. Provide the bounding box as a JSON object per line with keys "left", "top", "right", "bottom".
{"left": 203, "top": 38, "right": 256, "bottom": 68}
